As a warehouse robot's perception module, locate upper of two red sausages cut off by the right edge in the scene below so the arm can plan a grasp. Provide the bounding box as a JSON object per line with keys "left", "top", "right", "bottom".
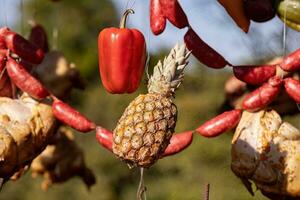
{"left": 280, "top": 49, "right": 300, "bottom": 72}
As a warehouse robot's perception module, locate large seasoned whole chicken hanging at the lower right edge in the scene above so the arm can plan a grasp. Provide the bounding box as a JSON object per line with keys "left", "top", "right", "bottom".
{"left": 231, "top": 110, "right": 300, "bottom": 199}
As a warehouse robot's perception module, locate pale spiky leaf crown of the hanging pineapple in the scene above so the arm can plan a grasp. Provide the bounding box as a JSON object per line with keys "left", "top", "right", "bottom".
{"left": 148, "top": 44, "right": 191, "bottom": 96}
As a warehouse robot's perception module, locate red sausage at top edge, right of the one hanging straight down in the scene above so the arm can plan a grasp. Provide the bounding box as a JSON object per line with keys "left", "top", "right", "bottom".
{"left": 160, "top": 0, "right": 189, "bottom": 28}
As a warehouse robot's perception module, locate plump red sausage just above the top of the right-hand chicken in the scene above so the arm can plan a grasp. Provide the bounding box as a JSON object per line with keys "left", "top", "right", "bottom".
{"left": 243, "top": 76, "right": 282, "bottom": 112}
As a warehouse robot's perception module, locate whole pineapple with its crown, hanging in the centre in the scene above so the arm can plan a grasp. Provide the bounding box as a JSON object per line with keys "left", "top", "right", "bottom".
{"left": 113, "top": 44, "right": 190, "bottom": 168}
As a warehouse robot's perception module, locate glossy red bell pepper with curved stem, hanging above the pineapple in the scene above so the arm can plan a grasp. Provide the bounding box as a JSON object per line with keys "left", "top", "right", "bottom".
{"left": 98, "top": 9, "right": 146, "bottom": 94}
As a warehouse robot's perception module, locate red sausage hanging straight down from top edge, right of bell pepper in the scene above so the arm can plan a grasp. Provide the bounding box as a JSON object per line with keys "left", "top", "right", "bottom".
{"left": 150, "top": 0, "right": 167, "bottom": 35}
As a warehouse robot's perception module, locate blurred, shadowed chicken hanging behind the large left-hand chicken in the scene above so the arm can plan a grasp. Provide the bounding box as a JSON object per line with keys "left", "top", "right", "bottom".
{"left": 31, "top": 126, "right": 96, "bottom": 190}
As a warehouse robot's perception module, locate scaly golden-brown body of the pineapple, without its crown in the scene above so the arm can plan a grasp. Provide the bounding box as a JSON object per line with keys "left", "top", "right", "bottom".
{"left": 113, "top": 93, "right": 177, "bottom": 167}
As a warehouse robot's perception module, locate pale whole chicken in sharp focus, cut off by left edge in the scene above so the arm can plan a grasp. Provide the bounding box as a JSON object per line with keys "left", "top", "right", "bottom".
{"left": 0, "top": 95, "right": 56, "bottom": 179}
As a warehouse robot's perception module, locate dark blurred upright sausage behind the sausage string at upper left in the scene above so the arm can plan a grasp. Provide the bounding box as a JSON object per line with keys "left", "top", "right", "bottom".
{"left": 29, "top": 24, "right": 49, "bottom": 52}
